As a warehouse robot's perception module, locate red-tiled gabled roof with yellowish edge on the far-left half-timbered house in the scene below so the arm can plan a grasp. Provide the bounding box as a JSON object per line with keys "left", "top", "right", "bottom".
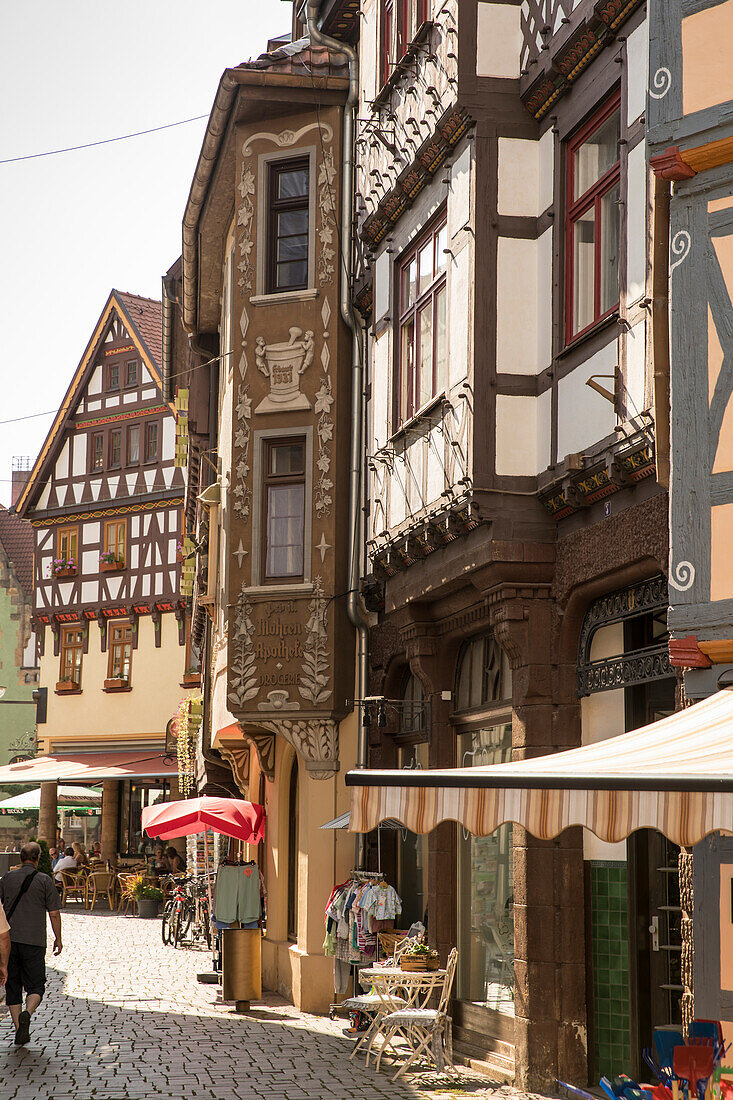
{"left": 12, "top": 290, "right": 166, "bottom": 516}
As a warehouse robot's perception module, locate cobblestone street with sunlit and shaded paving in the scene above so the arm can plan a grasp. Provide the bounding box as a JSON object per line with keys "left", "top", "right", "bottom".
{"left": 0, "top": 910, "right": 550, "bottom": 1100}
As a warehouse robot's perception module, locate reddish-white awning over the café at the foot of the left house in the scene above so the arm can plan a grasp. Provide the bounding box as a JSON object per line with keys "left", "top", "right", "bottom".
{"left": 0, "top": 749, "right": 178, "bottom": 785}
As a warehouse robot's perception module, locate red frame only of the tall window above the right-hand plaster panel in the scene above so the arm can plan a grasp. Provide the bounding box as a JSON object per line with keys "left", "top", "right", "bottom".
{"left": 565, "top": 89, "right": 621, "bottom": 343}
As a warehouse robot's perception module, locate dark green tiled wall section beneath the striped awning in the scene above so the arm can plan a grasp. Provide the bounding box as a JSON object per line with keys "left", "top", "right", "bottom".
{"left": 591, "top": 861, "right": 630, "bottom": 1080}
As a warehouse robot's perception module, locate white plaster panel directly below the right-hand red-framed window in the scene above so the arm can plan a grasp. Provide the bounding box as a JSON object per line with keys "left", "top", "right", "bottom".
{"left": 557, "top": 340, "right": 619, "bottom": 460}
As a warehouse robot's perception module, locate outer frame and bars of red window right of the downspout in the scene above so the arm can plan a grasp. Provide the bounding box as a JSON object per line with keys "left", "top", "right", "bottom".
{"left": 393, "top": 209, "right": 449, "bottom": 431}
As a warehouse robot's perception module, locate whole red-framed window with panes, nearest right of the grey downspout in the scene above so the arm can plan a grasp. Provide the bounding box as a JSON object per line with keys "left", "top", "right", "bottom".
{"left": 397, "top": 222, "right": 448, "bottom": 420}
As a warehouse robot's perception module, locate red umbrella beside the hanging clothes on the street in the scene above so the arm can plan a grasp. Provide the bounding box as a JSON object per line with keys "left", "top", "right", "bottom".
{"left": 142, "top": 798, "right": 265, "bottom": 844}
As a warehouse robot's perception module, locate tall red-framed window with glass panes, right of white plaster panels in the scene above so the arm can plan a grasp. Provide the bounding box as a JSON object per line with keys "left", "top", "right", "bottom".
{"left": 566, "top": 92, "right": 621, "bottom": 340}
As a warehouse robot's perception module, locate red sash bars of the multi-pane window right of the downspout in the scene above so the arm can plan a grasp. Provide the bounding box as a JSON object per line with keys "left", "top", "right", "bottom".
{"left": 395, "top": 216, "right": 448, "bottom": 429}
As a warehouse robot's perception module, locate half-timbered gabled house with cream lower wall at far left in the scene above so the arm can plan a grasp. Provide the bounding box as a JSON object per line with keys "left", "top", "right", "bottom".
{"left": 15, "top": 290, "right": 196, "bottom": 858}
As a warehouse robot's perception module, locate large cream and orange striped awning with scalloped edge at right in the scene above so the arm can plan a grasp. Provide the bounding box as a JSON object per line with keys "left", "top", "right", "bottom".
{"left": 346, "top": 691, "right": 733, "bottom": 847}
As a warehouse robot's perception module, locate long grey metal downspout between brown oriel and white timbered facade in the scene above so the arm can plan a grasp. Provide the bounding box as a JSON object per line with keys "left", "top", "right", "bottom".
{"left": 307, "top": 0, "right": 369, "bottom": 768}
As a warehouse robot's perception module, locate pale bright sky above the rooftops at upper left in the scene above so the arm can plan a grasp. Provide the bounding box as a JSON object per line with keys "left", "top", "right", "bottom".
{"left": 0, "top": 0, "right": 292, "bottom": 505}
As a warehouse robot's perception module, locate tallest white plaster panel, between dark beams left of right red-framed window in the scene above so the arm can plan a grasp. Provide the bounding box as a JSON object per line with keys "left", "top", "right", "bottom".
{"left": 496, "top": 238, "right": 534, "bottom": 374}
